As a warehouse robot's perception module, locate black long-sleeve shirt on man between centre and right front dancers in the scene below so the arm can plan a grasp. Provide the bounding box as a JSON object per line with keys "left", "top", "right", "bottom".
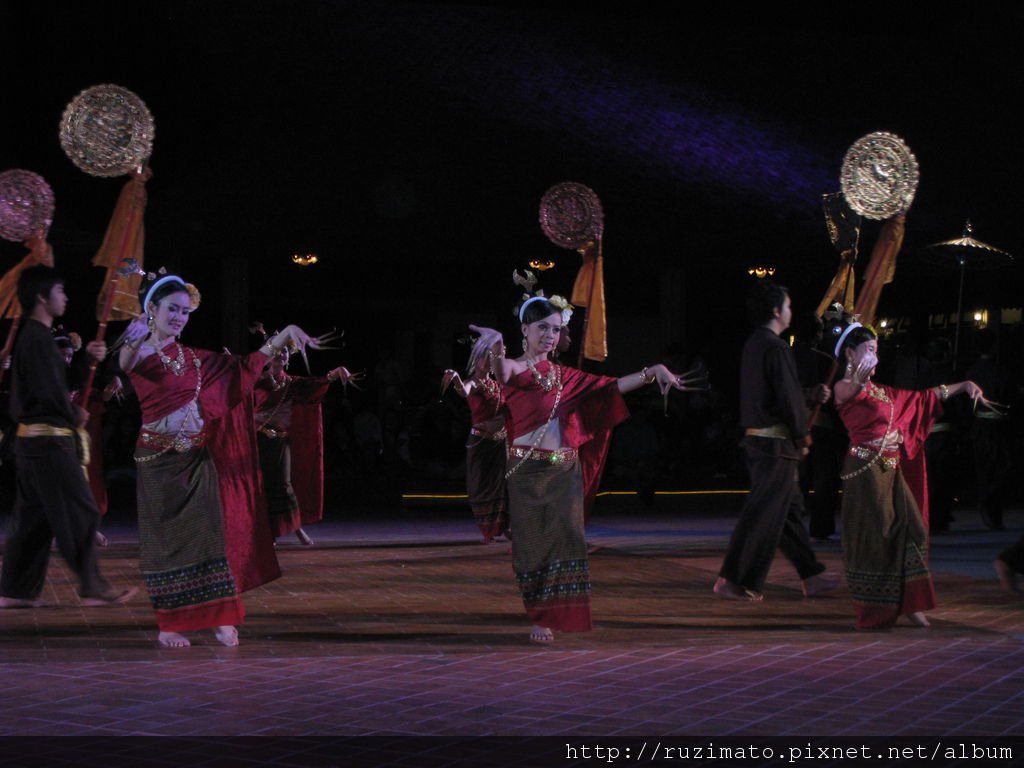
{"left": 739, "top": 326, "right": 807, "bottom": 441}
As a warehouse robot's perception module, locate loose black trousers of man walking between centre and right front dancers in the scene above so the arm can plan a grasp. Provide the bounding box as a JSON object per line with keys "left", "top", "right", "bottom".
{"left": 719, "top": 437, "right": 825, "bottom": 592}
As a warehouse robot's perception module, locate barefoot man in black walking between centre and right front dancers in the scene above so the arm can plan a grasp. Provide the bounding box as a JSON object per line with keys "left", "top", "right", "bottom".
{"left": 715, "top": 281, "right": 838, "bottom": 601}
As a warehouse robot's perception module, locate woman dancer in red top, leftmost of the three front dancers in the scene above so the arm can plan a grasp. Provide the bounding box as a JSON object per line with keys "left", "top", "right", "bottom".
{"left": 120, "top": 274, "right": 317, "bottom": 647}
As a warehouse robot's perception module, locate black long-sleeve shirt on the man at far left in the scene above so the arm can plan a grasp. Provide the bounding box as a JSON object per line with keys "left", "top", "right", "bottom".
{"left": 10, "top": 318, "right": 78, "bottom": 429}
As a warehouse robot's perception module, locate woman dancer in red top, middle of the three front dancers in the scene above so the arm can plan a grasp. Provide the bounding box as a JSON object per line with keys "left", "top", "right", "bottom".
{"left": 470, "top": 296, "right": 685, "bottom": 643}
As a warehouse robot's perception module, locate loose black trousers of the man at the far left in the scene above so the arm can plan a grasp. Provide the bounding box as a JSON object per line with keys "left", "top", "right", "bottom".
{"left": 0, "top": 437, "right": 111, "bottom": 600}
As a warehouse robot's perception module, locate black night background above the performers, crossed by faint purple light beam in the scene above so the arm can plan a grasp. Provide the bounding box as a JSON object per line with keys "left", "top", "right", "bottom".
{"left": 0, "top": 0, "right": 1024, "bottom": 505}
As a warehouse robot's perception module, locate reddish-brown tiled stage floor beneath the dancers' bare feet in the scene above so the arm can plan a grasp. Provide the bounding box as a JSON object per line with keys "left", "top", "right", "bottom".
{"left": 0, "top": 498, "right": 1024, "bottom": 765}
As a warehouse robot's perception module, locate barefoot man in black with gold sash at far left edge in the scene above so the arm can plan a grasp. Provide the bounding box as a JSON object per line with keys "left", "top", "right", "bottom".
{"left": 0, "top": 265, "right": 137, "bottom": 608}
